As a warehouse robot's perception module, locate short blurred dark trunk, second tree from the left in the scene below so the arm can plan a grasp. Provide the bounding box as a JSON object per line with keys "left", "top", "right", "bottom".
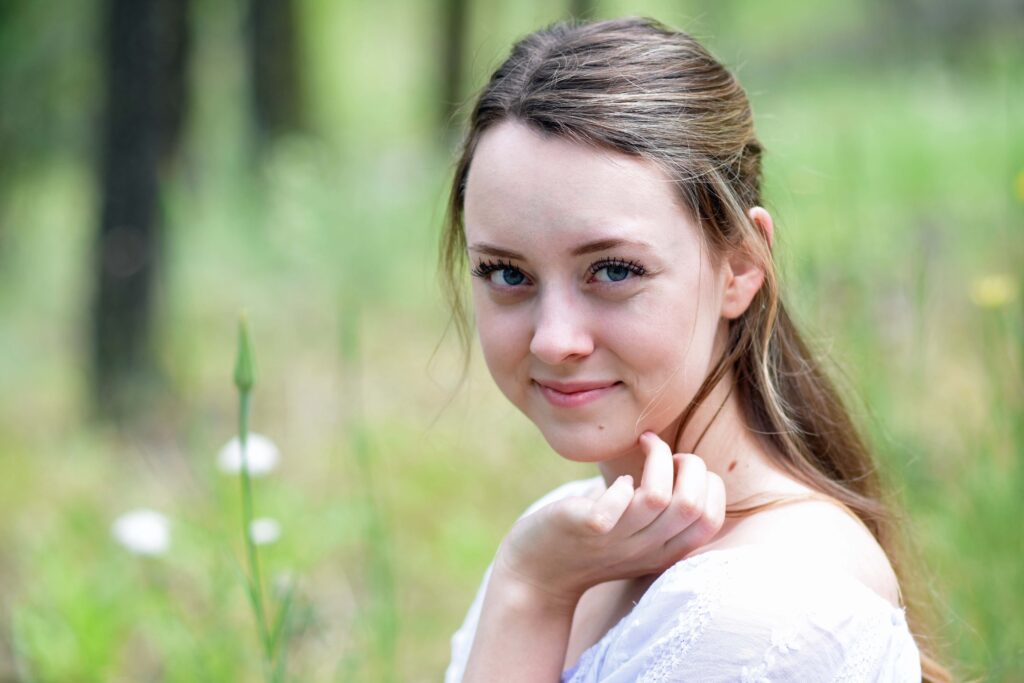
{"left": 247, "top": 0, "right": 303, "bottom": 144}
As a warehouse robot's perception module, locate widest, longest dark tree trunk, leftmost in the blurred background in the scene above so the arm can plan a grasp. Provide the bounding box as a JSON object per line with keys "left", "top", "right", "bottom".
{"left": 92, "top": 0, "right": 187, "bottom": 418}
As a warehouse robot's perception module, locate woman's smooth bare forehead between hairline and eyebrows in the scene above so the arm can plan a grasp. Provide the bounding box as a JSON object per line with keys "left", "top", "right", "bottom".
{"left": 464, "top": 121, "right": 696, "bottom": 252}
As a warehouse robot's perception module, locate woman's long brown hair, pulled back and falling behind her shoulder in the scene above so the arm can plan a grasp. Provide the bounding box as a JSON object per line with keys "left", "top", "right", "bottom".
{"left": 440, "top": 18, "right": 949, "bottom": 682}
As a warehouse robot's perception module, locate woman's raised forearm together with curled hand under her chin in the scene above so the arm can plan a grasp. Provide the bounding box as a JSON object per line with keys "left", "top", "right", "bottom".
{"left": 463, "top": 432, "right": 725, "bottom": 683}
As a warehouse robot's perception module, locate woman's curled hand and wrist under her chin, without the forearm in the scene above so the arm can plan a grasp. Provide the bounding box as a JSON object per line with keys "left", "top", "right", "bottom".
{"left": 495, "top": 432, "right": 725, "bottom": 606}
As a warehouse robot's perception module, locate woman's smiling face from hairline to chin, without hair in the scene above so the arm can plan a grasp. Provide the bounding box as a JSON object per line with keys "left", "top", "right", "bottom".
{"left": 465, "top": 122, "right": 725, "bottom": 462}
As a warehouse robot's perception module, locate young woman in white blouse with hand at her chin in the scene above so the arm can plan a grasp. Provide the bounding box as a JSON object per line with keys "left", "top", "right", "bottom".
{"left": 442, "top": 15, "right": 947, "bottom": 682}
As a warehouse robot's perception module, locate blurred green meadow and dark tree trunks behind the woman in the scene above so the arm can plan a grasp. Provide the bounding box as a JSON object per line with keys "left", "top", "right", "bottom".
{"left": 0, "top": 0, "right": 1024, "bottom": 681}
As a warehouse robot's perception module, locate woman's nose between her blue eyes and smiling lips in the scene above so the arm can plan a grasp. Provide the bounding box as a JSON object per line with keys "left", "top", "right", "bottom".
{"left": 529, "top": 292, "right": 594, "bottom": 366}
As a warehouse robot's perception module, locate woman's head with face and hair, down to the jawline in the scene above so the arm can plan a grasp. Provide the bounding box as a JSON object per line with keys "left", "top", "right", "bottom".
{"left": 442, "top": 18, "right": 776, "bottom": 460}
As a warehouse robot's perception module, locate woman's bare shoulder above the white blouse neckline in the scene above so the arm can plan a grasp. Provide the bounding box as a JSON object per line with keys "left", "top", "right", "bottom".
{"left": 700, "top": 501, "right": 900, "bottom": 606}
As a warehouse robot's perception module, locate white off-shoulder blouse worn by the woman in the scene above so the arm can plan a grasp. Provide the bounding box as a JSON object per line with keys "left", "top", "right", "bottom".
{"left": 444, "top": 476, "right": 921, "bottom": 683}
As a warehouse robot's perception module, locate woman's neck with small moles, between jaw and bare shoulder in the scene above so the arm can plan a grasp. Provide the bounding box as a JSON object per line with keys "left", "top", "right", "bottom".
{"left": 598, "top": 373, "right": 788, "bottom": 505}
